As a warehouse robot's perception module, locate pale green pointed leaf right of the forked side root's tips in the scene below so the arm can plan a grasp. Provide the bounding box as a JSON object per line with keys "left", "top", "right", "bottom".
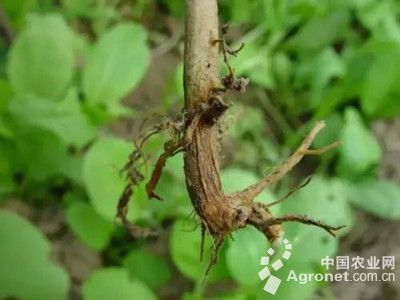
{"left": 338, "top": 108, "right": 382, "bottom": 174}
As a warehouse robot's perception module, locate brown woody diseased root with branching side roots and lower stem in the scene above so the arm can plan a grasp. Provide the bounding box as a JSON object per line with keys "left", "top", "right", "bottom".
{"left": 117, "top": 18, "right": 344, "bottom": 282}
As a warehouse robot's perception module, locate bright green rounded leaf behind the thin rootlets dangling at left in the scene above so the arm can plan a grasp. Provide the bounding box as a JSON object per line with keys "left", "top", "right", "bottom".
{"left": 83, "top": 136, "right": 147, "bottom": 221}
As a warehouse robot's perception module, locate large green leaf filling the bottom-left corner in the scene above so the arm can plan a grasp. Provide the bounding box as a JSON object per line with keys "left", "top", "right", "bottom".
{"left": 0, "top": 211, "right": 69, "bottom": 300}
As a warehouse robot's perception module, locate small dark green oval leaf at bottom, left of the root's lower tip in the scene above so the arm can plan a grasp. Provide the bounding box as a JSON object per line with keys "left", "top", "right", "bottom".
{"left": 124, "top": 250, "right": 171, "bottom": 289}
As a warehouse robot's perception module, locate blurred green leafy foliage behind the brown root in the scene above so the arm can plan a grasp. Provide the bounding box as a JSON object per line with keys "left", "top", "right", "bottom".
{"left": 0, "top": 0, "right": 400, "bottom": 299}
